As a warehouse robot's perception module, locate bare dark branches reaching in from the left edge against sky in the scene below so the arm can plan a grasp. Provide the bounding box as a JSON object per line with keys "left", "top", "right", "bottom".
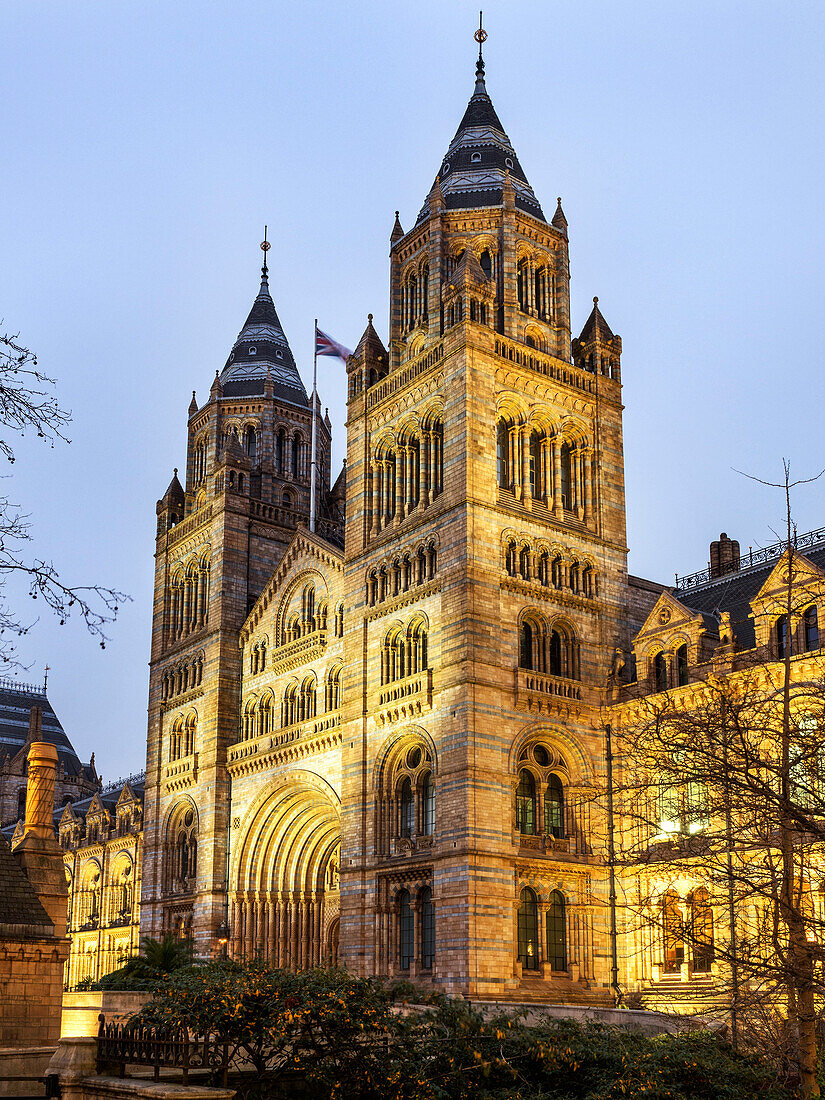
{"left": 0, "top": 333, "right": 130, "bottom": 668}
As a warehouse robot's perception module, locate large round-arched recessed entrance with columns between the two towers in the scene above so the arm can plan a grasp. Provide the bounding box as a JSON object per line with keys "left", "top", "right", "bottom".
{"left": 230, "top": 772, "right": 341, "bottom": 970}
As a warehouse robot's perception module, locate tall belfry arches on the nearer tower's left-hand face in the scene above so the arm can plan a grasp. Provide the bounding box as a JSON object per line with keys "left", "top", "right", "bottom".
{"left": 367, "top": 414, "right": 443, "bottom": 536}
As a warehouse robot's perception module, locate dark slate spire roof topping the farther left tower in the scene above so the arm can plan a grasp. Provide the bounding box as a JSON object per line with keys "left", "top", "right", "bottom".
{"left": 220, "top": 263, "right": 309, "bottom": 406}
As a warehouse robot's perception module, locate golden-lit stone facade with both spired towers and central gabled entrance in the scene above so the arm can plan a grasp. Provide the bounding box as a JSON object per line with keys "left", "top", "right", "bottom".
{"left": 141, "top": 45, "right": 822, "bottom": 1003}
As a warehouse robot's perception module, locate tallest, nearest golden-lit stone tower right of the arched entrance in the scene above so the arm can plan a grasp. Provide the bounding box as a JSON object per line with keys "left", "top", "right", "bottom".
{"left": 340, "top": 52, "right": 627, "bottom": 1001}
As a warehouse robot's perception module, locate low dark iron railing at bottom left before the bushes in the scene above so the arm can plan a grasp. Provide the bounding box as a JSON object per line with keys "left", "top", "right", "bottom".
{"left": 97, "top": 1012, "right": 229, "bottom": 1086}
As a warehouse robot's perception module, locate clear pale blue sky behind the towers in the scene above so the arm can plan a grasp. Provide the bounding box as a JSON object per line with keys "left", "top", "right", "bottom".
{"left": 0, "top": 0, "right": 825, "bottom": 778}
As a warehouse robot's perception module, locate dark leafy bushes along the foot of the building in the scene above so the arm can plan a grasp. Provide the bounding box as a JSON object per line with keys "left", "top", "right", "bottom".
{"left": 129, "top": 959, "right": 787, "bottom": 1100}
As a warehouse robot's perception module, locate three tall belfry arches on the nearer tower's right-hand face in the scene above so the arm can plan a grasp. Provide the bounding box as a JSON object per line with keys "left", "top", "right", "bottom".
{"left": 496, "top": 413, "right": 595, "bottom": 524}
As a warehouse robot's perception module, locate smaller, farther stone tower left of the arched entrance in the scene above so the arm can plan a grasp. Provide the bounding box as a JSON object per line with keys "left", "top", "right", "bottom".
{"left": 141, "top": 253, "right": 336, "bottom": 955}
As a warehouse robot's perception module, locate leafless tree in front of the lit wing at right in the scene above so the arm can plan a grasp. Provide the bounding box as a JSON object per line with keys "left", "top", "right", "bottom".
{"left": 613, "top": 463, "right": 825, "bottom": 1097}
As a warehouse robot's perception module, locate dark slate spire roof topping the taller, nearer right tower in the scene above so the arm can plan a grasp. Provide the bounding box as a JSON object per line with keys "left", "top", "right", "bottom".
{"left": 417, "top": 51, "right": 547, "bottom": 224}
